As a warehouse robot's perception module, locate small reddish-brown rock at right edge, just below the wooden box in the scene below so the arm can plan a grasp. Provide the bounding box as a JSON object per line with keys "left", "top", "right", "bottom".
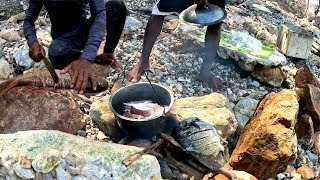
{"left": 295, "top": 65, "right": 320, "bottom": 88}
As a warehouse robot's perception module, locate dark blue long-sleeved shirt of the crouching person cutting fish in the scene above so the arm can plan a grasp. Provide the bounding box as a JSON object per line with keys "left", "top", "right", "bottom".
{"left": 23, "top": 0, "right": 106, "bottom": 60}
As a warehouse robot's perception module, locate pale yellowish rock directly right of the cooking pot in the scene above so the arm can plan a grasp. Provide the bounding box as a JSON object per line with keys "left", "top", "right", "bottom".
{"left": 171, "top": 93, "right": 238, "bottom": 139}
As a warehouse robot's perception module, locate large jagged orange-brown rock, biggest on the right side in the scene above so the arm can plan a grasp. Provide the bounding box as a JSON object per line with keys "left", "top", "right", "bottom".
{"left": 226, "top": 90, "right": 299, "bottom": 179}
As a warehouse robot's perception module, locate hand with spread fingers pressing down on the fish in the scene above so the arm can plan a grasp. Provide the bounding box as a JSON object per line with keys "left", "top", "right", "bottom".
{"left": 61, "top": 58, "right": 97, "bottom": 94}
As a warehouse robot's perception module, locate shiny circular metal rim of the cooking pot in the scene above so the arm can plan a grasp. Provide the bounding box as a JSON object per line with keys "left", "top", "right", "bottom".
{"left": 109, "top": 82, "right": 174, "bottom": 122}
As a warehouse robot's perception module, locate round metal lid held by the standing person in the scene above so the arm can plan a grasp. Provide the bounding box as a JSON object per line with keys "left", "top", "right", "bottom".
{"left": 179, "top": 4, "right": 227, "bottom": 26}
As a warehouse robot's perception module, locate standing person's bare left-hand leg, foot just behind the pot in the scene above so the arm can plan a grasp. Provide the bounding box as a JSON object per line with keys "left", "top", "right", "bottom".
{"left": 128, "top": 15, "right": 164, "bottom": 82}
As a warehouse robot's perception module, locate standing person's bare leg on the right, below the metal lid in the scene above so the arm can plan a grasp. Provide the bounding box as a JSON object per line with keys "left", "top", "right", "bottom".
{"left": 199, "top": 23, "right": 221, "bottom": 91}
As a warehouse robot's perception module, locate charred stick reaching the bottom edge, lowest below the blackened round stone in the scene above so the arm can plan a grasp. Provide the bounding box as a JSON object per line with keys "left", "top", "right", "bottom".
{"left": 164, "top": 150, "right": 204, "bottom": 180}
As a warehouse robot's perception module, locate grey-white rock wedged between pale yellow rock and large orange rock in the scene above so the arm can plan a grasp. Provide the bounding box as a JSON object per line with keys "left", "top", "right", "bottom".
{"left": 234, "top": 97, "right": 259, "bottom": 131}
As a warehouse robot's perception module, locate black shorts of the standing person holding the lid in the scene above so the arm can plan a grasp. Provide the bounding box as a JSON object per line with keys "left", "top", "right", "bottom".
{"left": 155, "top": 0, "right": 226, "bottom": 13}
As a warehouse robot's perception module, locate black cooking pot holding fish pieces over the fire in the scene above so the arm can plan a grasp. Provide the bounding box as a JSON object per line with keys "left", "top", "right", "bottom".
{"left": 109, "top": 82, "right": 174, "bottom": 138}
